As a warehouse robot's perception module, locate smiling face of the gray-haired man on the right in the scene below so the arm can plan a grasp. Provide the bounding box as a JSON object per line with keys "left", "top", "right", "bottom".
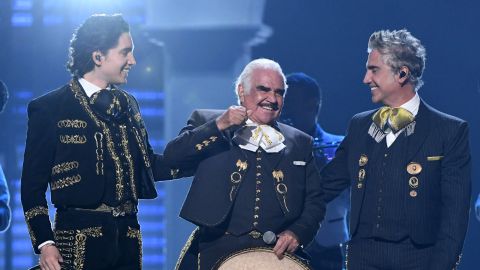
{"left": 363, "top": 50, "right": 415, "bottom": 107}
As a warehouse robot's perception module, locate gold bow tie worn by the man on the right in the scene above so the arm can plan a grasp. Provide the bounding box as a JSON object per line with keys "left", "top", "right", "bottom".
{"left": 372, "top": 106, "right": 415, "bottom": 133}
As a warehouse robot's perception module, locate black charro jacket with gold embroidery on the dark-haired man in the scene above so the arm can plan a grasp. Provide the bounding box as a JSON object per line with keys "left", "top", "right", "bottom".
{"left": 21, "top": 79, "right": 186, "bottom": 253}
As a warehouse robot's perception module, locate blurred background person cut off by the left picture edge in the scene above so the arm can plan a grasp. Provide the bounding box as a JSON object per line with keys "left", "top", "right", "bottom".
{"left": 0, "top": 78, "right": 10, "bottom": 231}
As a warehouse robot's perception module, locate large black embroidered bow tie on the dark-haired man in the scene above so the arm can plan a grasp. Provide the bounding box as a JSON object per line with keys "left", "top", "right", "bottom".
{"left": 90, "top": 89, "right": 128, "bottom": 121}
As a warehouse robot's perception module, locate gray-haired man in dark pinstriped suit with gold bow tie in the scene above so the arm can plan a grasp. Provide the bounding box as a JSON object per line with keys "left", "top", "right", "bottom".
{"left": 321, "top": 30, "right": 471, "bottom": 270}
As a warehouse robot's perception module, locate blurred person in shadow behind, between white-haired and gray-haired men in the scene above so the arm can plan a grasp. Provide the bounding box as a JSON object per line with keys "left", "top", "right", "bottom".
{"left": 280, "top": 73, "right": 349, "bottom": 270}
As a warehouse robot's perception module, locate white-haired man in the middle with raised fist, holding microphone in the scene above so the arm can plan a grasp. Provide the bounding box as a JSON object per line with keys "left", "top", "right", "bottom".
{"left": 164, "top": 59, "right": 325, "bottom": 269}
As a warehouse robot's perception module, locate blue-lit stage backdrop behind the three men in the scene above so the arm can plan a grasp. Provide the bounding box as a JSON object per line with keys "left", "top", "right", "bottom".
{"left": 0, "top": 0, "right": 480, "bottom": 270}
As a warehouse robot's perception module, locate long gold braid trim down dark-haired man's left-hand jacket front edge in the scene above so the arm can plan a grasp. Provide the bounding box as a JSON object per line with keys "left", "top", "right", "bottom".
{"left": 70, "top": 79, "right": 123, "bottom": 201}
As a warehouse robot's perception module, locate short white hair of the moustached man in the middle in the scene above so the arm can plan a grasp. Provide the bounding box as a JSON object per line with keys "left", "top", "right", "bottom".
{"left": 234, "top": 58, "right": 288, "bottom": 104}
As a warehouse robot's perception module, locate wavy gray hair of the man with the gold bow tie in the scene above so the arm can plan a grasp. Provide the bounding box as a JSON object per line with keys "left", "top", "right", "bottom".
{"left": 368, "top": 29, "right": 426, "bottom": 91}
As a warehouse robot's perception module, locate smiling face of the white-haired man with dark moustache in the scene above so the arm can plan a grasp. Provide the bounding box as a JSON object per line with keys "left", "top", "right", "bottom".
{"left": 237, "top": 69, "right": 285, "bottom": 125}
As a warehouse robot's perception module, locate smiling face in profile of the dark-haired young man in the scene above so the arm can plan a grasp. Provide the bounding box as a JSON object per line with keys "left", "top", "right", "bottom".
{"left": 92, "top": 33, "right": 136, "bottom": 85}
